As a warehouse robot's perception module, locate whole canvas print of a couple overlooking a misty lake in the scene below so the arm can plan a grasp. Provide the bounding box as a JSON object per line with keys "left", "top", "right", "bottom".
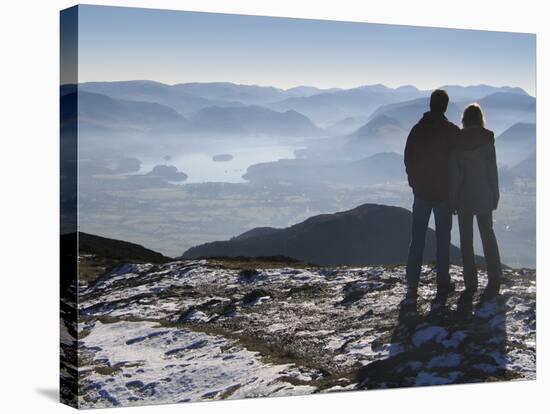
{"left": 60, "top": 5, "right": 536, "bottom": 408}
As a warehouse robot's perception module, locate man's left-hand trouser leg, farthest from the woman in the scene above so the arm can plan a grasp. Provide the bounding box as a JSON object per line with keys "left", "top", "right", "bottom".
{"left": 407, "top": 197, "right": 432, "bottom": 296}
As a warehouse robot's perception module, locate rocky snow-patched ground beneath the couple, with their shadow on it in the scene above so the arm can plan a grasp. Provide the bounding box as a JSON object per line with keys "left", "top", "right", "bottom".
{"left": 78, "top": 260, "right": 536, "bottom": 407}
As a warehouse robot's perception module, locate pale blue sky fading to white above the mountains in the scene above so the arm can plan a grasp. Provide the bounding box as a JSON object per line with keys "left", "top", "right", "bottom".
{"left": 75, "top": 6, "right": 536, "bottom": 95}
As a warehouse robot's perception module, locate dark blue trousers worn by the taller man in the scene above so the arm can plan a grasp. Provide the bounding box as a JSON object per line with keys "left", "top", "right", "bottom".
{"left": 407, "top": 197, "right": 453, "bottom": 290}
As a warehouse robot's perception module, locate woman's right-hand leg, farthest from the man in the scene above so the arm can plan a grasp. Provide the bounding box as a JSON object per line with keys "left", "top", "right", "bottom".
{"left": 477, "top": 212, "right": 502, "bottom": 294}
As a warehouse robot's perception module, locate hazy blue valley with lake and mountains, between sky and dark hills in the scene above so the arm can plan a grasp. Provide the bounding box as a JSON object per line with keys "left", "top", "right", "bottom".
{"left": 61, "top": 81, "right": 536, "bottom": 267}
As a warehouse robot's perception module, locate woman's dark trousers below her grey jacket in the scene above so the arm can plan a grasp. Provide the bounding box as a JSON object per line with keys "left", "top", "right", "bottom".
{"left": 458, "top": 212, "right": 502, "bottom": 291}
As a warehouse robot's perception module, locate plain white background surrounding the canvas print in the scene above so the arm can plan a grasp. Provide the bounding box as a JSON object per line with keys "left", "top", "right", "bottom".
{"left": 0, "top": 0, "right": 550, "bottom": 414}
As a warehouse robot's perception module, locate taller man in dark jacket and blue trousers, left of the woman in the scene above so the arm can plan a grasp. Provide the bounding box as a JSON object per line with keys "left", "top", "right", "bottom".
{"left": 405, "top": 89, "right": 460, "bottom": 298}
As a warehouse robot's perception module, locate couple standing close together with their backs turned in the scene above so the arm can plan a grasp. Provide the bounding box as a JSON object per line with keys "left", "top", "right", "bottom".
{"left": 405, "top": 89, "right": 502, "bottom": 298}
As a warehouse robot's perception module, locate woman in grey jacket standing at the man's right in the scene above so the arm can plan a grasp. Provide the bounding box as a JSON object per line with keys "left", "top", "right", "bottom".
{"left": 449, "top": 104, "right": 502, "bottom": 298}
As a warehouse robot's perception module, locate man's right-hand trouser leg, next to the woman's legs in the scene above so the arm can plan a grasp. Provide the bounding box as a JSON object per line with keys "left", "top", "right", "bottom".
{"left": 434, "top": 203, "right": 453, "bottom": 289}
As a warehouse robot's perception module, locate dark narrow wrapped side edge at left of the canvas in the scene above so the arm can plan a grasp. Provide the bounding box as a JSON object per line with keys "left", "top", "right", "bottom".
{"left": 59, "top": 6, "right": 79, "bottom": 408}
